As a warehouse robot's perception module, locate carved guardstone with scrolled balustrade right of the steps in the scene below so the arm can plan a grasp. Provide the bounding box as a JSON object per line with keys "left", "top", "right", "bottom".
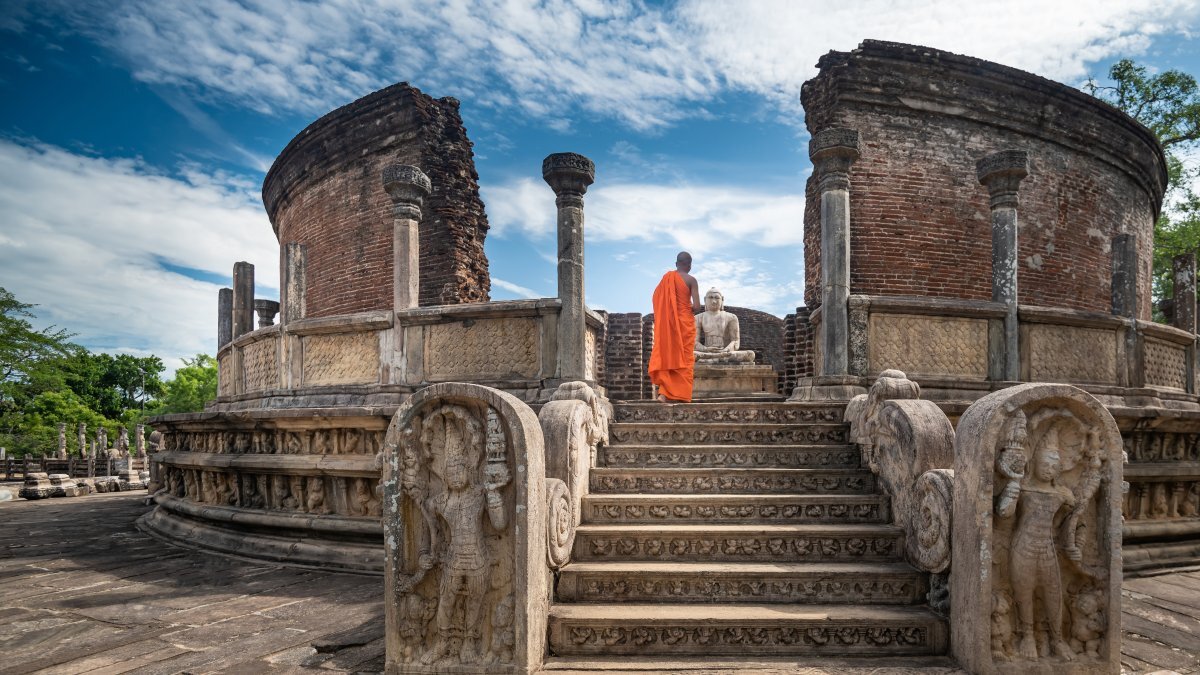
{"left": 847, "top": 370, "right": 1127, "bottom": 674}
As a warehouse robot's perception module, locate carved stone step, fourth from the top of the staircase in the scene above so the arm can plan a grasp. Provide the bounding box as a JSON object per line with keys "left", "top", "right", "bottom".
{"left": 588, "top": 467, "right": 875, "bottom": 495}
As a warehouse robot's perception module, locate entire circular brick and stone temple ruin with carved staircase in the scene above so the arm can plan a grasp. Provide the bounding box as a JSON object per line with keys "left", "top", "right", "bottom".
{"left": 140, "top": 41, "right": 1200, "bottom": 674}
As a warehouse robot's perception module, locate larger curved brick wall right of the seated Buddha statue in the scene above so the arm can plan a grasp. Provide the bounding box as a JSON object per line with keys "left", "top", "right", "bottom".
{"left": 802, "top": 41, "right": 1166, "bottom": 319}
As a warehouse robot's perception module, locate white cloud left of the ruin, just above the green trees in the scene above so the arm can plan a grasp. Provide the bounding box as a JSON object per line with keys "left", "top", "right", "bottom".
{"left": 0, "top": 139, "right": 278, "bottom": 369}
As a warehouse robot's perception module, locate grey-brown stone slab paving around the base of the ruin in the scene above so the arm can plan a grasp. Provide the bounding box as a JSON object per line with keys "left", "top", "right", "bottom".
{"left": 0, "top": 492, "right": 1200, "bottom": 675}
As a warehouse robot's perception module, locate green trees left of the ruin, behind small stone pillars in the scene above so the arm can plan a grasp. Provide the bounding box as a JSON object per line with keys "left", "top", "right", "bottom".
{"left": 0, "top": 287, "right": 217, "bottom": 456}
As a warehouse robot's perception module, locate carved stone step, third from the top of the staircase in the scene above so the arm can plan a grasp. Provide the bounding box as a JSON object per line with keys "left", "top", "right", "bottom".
{"left": 598, "top": 444, "right": 862, "bottom": 468}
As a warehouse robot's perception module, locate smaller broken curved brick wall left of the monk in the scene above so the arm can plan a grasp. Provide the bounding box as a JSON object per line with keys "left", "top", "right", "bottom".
{"left": 263, "top": 83, "right": 491, "bottom": 317}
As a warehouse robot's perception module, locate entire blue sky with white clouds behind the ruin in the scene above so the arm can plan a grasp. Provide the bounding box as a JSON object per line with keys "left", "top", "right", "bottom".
{"left": 0, "top": 0, "right": 1200, "bottom": 369}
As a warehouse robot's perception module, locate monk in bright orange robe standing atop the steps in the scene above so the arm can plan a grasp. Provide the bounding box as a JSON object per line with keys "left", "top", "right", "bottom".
{"left": 648, "top": 251, "right": 704, "bottom": 404}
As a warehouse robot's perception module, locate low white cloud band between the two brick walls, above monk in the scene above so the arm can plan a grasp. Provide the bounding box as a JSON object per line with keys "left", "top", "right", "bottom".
{"left": 482, "top": 178, "right": 804, "bottom": 255}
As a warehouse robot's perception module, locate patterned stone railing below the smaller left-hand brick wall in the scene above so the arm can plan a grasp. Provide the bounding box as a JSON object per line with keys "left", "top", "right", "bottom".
{"left": 215, "top": 298, "right": 605, "bottom": 410}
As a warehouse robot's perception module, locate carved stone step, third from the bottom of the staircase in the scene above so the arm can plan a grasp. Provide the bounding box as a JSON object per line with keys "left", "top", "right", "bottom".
{"left": 572, "top": 524, "right": 904, "bottom": 562}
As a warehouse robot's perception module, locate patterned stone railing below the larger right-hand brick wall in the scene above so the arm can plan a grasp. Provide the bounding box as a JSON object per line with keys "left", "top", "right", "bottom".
{"left": 810, "top": 295, "right": 1200, "bottom": 401}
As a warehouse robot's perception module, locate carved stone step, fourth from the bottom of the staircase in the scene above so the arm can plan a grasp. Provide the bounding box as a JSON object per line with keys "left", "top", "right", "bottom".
{"left": 583, "top": 494, "right": 890, "bottom": 525}
